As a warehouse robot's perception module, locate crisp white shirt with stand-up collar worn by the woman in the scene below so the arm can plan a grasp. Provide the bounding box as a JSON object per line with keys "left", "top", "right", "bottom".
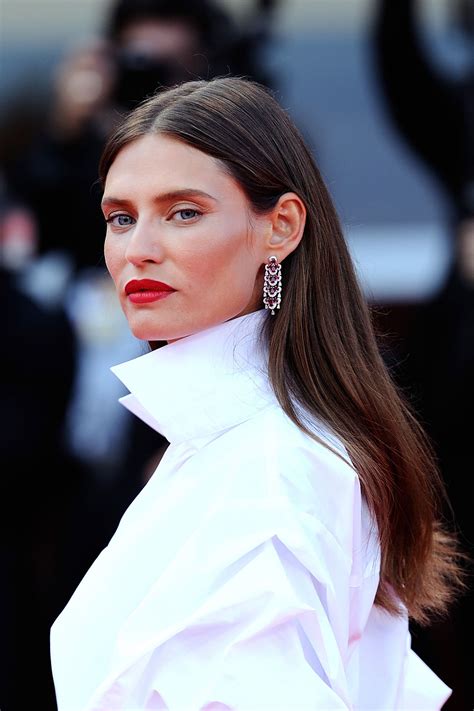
{"left": 51, "top": 310, "right": 450, "bottom": 711}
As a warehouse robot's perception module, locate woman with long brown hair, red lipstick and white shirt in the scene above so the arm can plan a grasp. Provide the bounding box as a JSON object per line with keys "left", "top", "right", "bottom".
{"left": 51, "top": 78, "right": 458, "bottom": 711}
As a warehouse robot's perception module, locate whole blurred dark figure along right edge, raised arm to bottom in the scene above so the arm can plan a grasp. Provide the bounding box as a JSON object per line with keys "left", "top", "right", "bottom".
{"left": 371, "top": 0, "right": 474, "bottom": 711}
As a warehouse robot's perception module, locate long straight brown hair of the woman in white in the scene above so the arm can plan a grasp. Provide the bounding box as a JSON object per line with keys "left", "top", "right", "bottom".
{"left": 99, "top": 77, "right": 460, "bottom": 622}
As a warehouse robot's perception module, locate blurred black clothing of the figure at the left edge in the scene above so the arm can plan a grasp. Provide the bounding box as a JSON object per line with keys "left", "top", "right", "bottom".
{"left": 0, "top": 270, "right": 80, "bottom": 711}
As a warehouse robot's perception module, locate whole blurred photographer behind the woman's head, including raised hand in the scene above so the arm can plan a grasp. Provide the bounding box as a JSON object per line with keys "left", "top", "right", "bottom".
{"left": 6, "top": 0, "right": 275, "bottom": 270}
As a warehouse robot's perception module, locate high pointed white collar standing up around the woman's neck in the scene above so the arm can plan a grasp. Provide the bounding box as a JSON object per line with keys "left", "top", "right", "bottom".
{"left": 111, "top": 309, "right": 275, "bottom": 443}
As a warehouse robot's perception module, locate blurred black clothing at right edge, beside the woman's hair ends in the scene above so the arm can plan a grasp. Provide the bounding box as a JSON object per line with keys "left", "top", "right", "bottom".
{"left": 400, "top": 271, "right": 474, "bottom": 711}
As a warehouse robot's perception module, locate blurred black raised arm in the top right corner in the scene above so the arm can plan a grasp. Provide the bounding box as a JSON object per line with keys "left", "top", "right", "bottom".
{"left": 370, "top": 0, "right": 464, "bottom": 203}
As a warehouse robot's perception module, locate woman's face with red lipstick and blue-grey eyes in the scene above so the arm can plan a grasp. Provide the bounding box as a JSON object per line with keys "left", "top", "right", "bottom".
{"left": 102, "top": 134, "right": 269, "bottom": 341}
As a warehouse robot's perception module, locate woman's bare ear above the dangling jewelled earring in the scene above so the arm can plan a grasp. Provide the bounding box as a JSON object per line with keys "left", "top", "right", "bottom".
{"left": 265, "top": 192, "right": 306, "bottom": 262}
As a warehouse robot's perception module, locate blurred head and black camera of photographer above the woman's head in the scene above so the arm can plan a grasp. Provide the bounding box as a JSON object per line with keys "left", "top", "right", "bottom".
{"left": 105, "top": 0, "right": 274, "bottom": 109}
